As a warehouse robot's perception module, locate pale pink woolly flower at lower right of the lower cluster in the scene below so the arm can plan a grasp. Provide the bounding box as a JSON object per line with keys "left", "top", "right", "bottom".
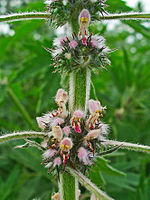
{"left": 78, "top": 147, "right": 92, "bottom": 165}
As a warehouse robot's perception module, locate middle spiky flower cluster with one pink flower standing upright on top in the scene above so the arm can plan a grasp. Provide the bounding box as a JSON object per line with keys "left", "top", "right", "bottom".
{"left": 45, "top": 9, "right": 111, "bottom": 72}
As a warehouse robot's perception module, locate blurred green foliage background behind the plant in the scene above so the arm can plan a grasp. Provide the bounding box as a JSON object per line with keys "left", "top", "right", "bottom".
{"left": 0, "top": 0, "right": 150, "bottom": 200}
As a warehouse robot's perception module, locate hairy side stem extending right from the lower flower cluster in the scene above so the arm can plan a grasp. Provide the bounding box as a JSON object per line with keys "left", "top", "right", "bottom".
{"left": 104, "top": 140, "right": 150, "bottom": 153}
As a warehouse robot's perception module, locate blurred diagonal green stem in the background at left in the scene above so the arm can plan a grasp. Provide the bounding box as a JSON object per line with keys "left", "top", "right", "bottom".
{"left": 7, "top": 87, "right": 37, "bottom": 130}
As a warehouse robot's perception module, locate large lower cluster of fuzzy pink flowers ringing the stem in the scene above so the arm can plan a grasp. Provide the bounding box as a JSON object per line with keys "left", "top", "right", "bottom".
{"left": 36, "top": 89, "right": 108, "bottom": 171}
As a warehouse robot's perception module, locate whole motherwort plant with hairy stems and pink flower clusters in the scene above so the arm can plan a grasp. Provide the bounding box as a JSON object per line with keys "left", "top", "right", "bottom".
{"left": 0, "top": 0, "right": 150, "bottom": 200}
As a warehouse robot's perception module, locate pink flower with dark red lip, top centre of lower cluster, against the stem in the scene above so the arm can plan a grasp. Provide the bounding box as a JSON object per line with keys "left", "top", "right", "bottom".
{"left": 71, "top": 110, "right": 84, "bottom": 133}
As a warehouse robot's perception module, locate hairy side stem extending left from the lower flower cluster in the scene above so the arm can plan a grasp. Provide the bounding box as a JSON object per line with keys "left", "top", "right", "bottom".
{"left": 0, "top": 131, "right": 46, "bottom": 143}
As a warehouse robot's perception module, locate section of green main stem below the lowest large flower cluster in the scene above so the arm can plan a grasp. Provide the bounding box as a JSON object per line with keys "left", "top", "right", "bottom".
{"left": 59, "top": 172, "right": 78, "bottom": 200}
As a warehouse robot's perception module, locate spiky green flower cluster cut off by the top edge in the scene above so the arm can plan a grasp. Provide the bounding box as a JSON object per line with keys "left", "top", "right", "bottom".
{"left": 45, "top": 0, "right": 107, "bottom": 27}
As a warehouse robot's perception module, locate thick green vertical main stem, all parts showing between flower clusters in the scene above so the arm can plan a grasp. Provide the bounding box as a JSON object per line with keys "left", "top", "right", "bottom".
{"left": 59, "top": 9, "right": 91, "bottom": 200}
